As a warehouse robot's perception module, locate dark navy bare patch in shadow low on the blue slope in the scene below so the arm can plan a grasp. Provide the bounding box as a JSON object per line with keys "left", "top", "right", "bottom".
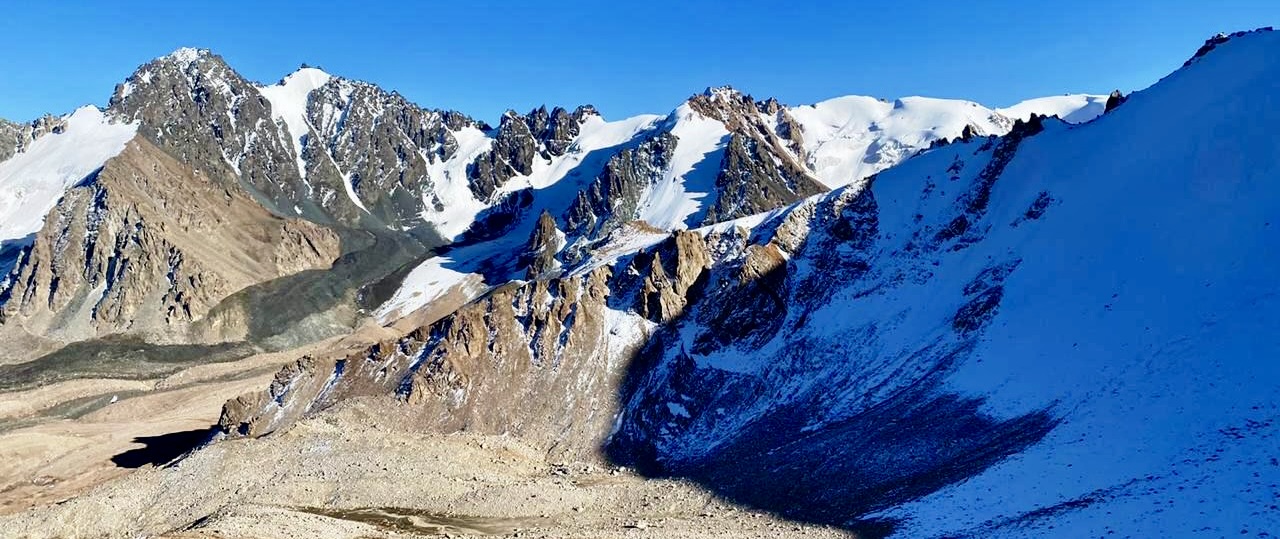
{"left": 603, "top": 236, "right": 1059, "bottom": 538}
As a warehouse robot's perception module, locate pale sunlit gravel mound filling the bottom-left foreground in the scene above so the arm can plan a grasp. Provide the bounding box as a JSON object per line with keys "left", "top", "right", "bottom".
{"left": 0, "top": 403, "right": 849, "bottom": 539}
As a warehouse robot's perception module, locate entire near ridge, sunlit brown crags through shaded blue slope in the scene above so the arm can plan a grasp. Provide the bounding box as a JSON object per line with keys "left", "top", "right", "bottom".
{"left": 220, "top": 32, "right": 1280, "bottom": 536}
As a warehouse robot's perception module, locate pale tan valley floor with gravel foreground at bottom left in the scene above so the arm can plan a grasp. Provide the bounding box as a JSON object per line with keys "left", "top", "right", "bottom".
{"left": 0, "top": 343, "right": 847, "bottom": 539}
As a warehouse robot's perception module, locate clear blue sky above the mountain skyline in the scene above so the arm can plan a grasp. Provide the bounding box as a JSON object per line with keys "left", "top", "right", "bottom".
{"left": 0, "top": 0, "right": 1280, "bottom": 122}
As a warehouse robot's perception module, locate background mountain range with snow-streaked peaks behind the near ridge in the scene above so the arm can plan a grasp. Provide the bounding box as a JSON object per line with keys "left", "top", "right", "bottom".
{"left": 0, "top": 49, "right": 1087, "bottom": 342}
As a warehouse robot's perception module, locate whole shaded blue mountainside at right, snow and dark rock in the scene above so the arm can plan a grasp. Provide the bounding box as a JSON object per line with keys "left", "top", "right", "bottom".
{"left": 612, "top": 32, "right": 1280, "bottom": 538}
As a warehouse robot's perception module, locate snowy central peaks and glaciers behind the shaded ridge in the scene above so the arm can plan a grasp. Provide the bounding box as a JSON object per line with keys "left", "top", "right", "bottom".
{"left": 380, "top": 88, "right": 1101, "bottom": 320}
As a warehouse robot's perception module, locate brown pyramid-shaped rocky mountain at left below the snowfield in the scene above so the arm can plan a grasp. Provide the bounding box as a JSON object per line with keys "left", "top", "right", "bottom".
{"left": 0, "top": 137, "right": 338, "bottom": 341}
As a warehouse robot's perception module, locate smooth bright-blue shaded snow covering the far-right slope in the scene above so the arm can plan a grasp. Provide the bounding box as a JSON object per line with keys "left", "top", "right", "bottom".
{"left": 877, "top": 32, "right": 1280, "bottom": 536}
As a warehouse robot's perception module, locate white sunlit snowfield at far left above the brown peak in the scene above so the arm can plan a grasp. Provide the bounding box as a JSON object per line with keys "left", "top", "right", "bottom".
{"left": 0, "top": 106, "right": 138, "bottom": 242}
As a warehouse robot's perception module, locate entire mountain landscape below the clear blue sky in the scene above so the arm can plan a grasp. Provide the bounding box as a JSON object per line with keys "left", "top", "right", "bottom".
{"left": 0, "top": 23, "right": 1280, "bottom": 538}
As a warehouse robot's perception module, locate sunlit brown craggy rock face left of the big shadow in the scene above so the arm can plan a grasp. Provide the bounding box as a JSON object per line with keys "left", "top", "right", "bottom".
{"left": 220, "top": 268, "right": 644, "bottom": 458}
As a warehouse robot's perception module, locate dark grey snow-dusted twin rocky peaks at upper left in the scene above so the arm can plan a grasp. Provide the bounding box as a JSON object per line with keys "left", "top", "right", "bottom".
{"left": 109, "top": 50, "right": 483, "bottom": 233}
